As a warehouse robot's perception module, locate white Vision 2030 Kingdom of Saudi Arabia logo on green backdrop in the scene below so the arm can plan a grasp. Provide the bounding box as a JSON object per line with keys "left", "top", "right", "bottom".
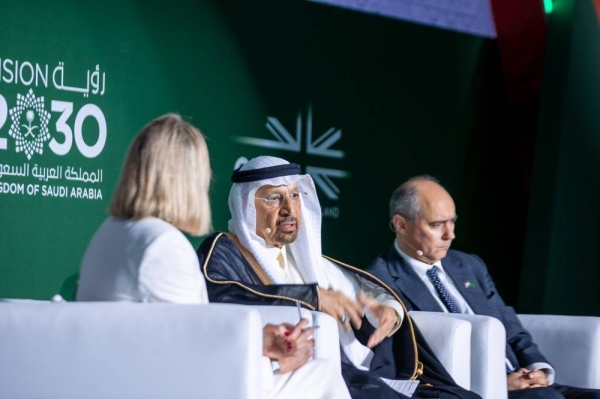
{"left": 0, "top": 58, "right": 107, "bottom": 200}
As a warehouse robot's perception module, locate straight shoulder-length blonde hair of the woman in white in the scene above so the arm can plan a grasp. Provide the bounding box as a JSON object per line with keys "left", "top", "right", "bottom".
{"left": 109, "top": 114, "right": 211, "bottom": 235}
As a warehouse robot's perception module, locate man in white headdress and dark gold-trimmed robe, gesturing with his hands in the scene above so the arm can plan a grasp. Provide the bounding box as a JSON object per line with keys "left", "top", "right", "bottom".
{"left": 198, "top": 156, "right": 478, "bottom": 399}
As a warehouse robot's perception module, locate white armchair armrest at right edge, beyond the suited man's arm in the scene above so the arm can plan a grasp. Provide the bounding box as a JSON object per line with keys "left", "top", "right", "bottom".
{"left": 518, "top": 314, "right": 600, "bottom": 389}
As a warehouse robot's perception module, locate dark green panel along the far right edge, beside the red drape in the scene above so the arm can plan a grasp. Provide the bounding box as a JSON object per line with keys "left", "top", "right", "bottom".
{"left": 519, "top": 0, "right": 600, "bottom": 315}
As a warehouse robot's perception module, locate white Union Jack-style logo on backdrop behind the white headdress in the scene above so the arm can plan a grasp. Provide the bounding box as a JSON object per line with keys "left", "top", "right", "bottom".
{"left": 235, "top": 104, "right": 350, "bottom": 200}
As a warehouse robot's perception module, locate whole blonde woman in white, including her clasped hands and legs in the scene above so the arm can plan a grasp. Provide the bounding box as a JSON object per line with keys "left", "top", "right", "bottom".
{"left": 77, "top": 114, "right": 349, "bottom": 399}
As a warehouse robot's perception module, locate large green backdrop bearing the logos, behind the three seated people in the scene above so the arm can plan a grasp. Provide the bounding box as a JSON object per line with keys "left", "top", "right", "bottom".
{"left": 0, "top": 0, "right": 592, "bottom": 318}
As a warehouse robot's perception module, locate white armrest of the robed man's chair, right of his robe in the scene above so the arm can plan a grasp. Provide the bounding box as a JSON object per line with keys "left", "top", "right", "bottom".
{"left": 410, "top": 311, "right": 471, "bottom": 389}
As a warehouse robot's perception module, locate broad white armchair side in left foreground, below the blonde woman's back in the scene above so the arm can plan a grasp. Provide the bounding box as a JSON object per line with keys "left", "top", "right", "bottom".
{"left": 0, "top": 302, "right": 262, "bottom": 399}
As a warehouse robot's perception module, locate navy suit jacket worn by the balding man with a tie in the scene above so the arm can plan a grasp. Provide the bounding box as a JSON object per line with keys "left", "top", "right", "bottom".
{"left": 369, "top": 245, "right": 550, "bottom": 367}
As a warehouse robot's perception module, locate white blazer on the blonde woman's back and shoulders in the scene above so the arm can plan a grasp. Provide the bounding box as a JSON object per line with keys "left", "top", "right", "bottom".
{"left": 77, "top": 217, "right": 208, "bottom": 303}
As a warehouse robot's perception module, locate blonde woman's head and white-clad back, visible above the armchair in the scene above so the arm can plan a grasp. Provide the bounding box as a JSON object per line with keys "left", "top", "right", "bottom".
{"left": 77, "top": 114, "right": 211, "bottom": 303}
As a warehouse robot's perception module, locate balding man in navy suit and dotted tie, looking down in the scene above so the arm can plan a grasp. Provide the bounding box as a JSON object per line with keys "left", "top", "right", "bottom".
{"left": 369, "top": 176, "right": 600, "bottom": 399}
